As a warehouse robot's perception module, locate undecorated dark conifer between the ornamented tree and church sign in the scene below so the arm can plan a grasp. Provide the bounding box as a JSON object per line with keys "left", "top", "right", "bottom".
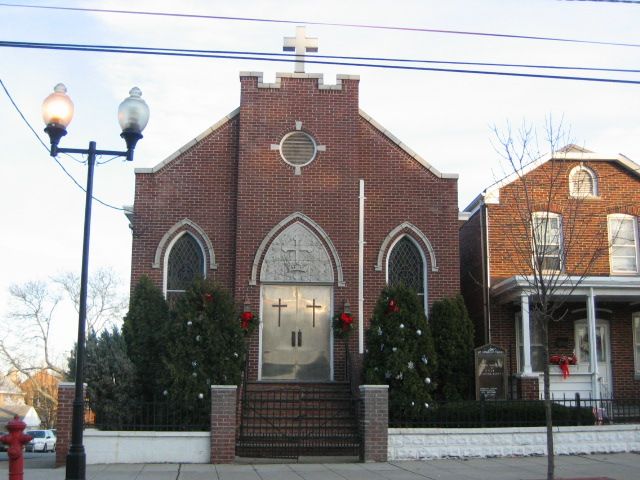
{"left": 429, "top": 295, "right": 474, "bottom": 401}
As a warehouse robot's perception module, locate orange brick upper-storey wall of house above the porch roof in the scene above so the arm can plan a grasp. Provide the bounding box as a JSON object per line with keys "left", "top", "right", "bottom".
{"left": 487, "top": 161, "right": 640, "bottom": 284}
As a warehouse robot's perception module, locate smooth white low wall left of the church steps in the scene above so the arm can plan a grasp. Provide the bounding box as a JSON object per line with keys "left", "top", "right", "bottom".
{"left": 84, "top": 429, "right": 211, "bottom": 465}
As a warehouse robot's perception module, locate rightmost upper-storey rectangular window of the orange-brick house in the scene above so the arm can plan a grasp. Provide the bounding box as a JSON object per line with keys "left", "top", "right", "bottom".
{"left": 607, "top": 214, "right": 638, "bottom": 273}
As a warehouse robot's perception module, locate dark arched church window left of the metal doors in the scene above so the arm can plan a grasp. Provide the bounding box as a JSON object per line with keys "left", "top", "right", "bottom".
{"left": 166, "top": 233, "right": 204, "bottom": 300}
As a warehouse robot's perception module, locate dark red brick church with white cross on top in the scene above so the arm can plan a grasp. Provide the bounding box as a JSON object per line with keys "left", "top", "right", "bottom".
{"left": 130, "top": 30, "right": 459, "bottom": 454}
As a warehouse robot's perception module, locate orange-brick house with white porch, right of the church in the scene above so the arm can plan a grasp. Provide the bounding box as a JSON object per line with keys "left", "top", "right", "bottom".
{"left": 460, "top": 145, "right": 640, "bottom": 399}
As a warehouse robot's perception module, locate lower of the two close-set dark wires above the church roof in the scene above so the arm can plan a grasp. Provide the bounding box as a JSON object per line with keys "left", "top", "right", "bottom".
{"left": 0, "top": 41, "right": 640, "bottom": 85}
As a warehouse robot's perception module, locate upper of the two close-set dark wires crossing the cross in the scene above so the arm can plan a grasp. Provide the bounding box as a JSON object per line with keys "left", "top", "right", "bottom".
{"left": 5, "top": 40, "right": 640, "bottom": 73}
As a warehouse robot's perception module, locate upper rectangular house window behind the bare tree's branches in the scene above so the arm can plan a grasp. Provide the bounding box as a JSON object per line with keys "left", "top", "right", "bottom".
{"left": 532, "top": 212, "right": 562, "bottom": 272}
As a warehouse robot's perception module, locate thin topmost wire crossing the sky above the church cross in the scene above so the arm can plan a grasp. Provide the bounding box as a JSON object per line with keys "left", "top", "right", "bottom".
{"left": 0, "top": 3, "right": 640, "bottom": 47}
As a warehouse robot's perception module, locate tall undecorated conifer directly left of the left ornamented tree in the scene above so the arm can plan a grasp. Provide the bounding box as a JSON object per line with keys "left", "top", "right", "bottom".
{"left": 122, "top": 276, "right": 169, "bottom": 402}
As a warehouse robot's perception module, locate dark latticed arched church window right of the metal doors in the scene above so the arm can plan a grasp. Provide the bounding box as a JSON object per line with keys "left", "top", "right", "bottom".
{"left": 388, "top": 236, "right": 425, "bottom": 296}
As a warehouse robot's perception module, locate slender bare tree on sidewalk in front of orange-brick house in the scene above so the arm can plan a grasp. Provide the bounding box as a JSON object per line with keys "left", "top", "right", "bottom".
{"left": 494, "top": 119, "right": 609, "bottom": 480}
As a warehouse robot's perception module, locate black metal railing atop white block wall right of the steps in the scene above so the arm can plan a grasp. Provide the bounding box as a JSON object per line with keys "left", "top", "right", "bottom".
{"left": 389, "top": 395, "right": 640, "bottom": 428}
